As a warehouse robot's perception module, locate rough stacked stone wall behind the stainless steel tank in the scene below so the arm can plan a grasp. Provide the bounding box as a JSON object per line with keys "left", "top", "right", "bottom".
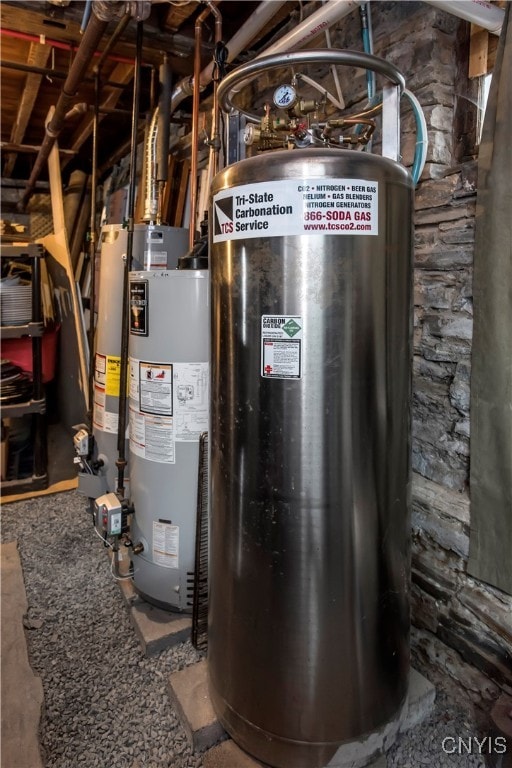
{"left": 328, "top": 2, "right": 512, "bottom": 708}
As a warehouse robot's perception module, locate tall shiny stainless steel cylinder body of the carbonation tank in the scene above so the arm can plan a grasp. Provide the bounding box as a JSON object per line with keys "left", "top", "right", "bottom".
{"left": 208, "top": 149, "right": 413, "bottom": 768}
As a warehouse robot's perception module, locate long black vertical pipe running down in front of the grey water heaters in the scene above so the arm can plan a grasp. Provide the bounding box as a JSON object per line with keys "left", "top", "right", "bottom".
{"left": 116, "top": 21, "right": 143, "bottom": 498}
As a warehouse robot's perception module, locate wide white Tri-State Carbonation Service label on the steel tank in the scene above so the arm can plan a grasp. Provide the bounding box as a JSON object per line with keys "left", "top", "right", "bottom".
{"left": 213, "top": 177, "right": 379, "bottom": 243}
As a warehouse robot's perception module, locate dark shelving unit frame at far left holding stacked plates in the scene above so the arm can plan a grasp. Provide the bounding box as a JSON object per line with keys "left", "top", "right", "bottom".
{"left": 0, "top": 243, "right": 48, "bottom": 496}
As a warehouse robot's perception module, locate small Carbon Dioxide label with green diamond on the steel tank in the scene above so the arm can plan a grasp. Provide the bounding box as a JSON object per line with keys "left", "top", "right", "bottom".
{"left": 261, "top": 315, "right": 303, "bottom": 379}
